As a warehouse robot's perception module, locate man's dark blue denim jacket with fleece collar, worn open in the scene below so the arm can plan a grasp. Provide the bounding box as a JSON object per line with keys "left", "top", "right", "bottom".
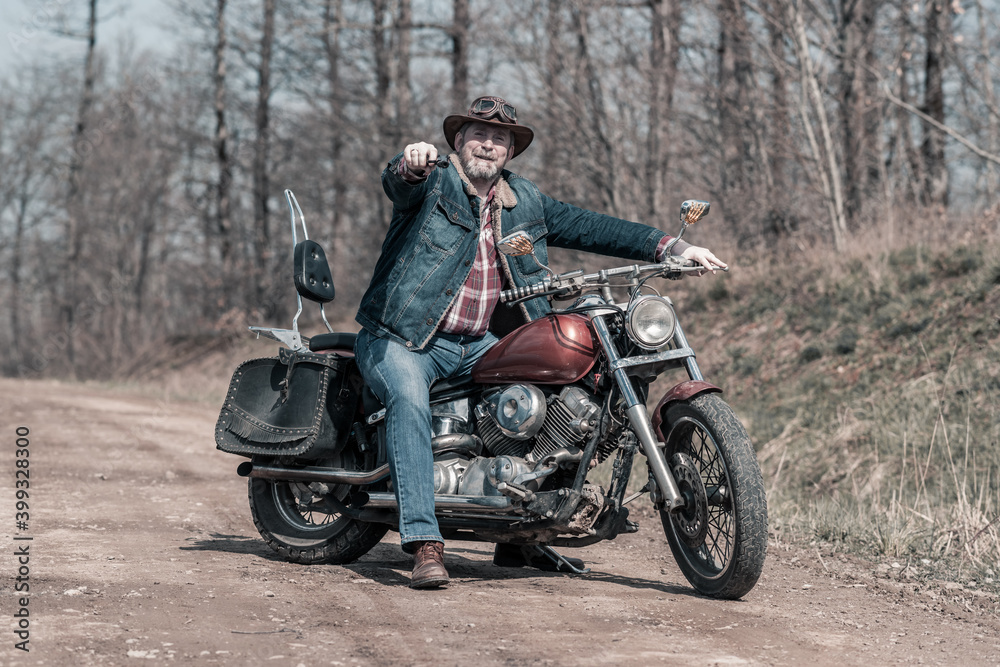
{"left": 356, "top": 154, "right": 665, "bottom": 349}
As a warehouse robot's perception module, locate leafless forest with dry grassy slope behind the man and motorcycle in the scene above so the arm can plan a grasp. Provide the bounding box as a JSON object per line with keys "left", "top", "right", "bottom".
{"left": 0, "top": 0, "right": 1000, "bottom": 586}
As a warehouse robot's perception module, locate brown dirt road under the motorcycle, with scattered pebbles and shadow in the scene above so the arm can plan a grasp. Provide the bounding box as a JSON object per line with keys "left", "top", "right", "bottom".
{"left": 0, "top": 380, "right": 1000, "bottom": 667}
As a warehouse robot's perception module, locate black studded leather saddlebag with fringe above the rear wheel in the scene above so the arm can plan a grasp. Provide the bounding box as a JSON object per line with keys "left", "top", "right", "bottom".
{"left": 215, "top": 349, "right": 362, "bottom": 460}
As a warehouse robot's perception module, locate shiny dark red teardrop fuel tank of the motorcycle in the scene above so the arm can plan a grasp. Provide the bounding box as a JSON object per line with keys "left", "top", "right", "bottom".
{"left": 472, "top": 314, "right": 600, "bottom": 384}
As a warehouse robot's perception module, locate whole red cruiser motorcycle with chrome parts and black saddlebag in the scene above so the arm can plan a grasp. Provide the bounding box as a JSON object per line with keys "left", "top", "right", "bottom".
{"left": 216, "top": 190, "right": 767, "bottom": 599}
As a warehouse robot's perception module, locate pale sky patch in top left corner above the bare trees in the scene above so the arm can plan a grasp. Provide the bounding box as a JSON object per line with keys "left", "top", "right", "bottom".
{"left": 0, "top": 0, "right": 173, "bottom": 72}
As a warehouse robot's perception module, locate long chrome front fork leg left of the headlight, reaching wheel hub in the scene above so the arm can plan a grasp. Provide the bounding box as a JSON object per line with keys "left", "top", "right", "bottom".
{"left": 590, "top": 311, "right": 688, "bottom": 512}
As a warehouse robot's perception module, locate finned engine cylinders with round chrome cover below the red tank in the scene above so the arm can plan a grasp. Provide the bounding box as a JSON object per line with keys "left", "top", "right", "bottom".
{"left": 475, "top": 384, "right": 600, "bottom": 462}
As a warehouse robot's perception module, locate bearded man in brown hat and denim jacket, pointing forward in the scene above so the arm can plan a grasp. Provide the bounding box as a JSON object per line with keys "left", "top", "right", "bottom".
{"left": 355, "top": 97, "right": 726, "bottom": 588}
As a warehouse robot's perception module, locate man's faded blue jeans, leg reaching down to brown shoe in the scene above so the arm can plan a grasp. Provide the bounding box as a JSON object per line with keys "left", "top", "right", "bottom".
{"left": 354, "top": 329, "right": 497, "bottom": 553}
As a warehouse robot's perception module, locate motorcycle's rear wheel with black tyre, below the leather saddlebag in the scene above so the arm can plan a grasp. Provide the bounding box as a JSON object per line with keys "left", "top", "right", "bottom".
{"left": 247, "top": 453, "right": 389, "bottom": 565}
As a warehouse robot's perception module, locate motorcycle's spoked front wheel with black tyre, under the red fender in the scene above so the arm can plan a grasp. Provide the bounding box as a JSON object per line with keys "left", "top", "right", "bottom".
{"left": 660, "top": 394, "right": 767, "bottom": 600}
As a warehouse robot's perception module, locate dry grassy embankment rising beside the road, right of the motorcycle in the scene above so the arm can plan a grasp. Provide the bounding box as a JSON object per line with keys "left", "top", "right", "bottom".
{"left": 673, "top": 217, "right": 1000, "bottom": 586}
